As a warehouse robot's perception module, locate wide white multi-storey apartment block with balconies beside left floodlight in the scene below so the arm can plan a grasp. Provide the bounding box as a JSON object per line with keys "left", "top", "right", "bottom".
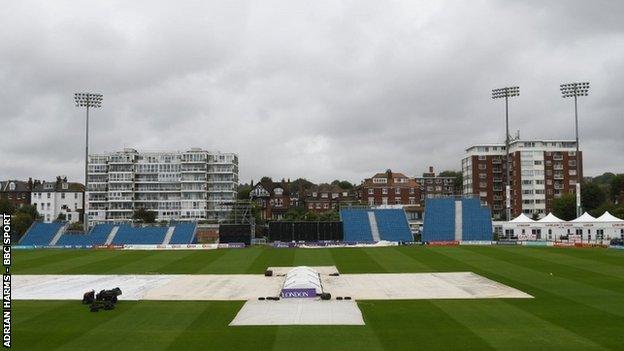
{"left": 87, "top": 148, "right": 238, "bottom": 223}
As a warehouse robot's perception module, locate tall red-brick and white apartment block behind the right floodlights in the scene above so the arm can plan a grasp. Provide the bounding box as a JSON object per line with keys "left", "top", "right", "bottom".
{"left": 462, "top": 140, "right": 583, "bottom": 219}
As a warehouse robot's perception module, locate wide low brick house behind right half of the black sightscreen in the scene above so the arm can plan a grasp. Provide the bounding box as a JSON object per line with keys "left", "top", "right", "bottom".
{"left": 303, "top": 184, "right": 359, "bottom": 213}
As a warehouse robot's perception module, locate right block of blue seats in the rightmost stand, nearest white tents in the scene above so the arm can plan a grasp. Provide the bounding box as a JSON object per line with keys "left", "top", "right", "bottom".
{"left": 462, "top": 198, "right": 492, "bottom": 240}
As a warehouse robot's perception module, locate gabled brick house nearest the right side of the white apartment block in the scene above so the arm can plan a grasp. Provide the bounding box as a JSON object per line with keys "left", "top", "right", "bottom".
{"left": 249, "top": 181, "right": 299, "bottom": 220}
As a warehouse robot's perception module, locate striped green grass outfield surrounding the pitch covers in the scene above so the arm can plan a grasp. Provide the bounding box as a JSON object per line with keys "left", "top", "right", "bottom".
{"left": 12, "top": 246, "right": 624, "bottom": 351}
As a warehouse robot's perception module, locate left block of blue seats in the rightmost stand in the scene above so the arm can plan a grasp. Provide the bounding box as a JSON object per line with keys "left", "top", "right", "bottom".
{"left": 422, "top": 198, "right": 455, "bottom": 241}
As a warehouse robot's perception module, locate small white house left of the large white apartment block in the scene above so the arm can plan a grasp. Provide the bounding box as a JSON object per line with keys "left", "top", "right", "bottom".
{"left": 30, "top": 177, "right": 84, "bottom": 223}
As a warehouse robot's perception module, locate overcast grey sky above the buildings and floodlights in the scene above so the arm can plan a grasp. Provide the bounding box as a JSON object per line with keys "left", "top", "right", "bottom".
{"left": 0, "top": 0, "right": 624, "bottom": 183}
